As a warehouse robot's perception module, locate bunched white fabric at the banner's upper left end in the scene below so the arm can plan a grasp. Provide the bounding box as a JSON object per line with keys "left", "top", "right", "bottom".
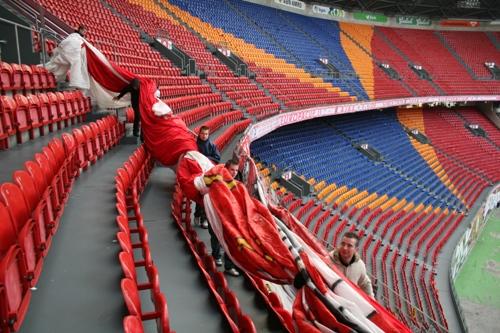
{"left": 45, "top": 32, "right": 90, "bottom": 89}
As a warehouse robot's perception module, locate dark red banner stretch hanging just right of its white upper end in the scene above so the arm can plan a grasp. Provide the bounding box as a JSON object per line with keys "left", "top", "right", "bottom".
{"left": 84, "top": 44, "right": 136, "bottom": 92}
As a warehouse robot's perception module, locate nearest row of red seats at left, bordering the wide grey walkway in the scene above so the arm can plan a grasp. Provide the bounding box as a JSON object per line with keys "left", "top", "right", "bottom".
{"left": 0, "top": 116, "right": 124, "bottom": 333}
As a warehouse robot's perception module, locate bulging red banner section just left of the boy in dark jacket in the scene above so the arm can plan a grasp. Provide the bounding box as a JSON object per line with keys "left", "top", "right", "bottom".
{"left": 139, "top": 79, "right": 198, "bottom": 165}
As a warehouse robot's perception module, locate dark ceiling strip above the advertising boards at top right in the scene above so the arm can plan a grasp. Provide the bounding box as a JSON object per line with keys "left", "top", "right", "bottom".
{"left": 308, "top": 0, "right": 500, "bottom": 20}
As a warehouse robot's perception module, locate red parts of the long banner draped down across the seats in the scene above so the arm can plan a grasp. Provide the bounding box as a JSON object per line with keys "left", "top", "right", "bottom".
{"left": 81, "top": 41, "right": 410, "bottom": 332}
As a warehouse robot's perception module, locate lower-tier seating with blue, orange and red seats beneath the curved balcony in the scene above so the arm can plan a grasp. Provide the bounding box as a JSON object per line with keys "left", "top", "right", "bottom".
{"left": 252, "top": 105, "right": 498, "bottom": 331}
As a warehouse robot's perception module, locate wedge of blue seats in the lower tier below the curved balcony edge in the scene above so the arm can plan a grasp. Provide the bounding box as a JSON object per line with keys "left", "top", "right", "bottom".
{"left": 252, "top": 113, "right": 460, "bottom": 207}
